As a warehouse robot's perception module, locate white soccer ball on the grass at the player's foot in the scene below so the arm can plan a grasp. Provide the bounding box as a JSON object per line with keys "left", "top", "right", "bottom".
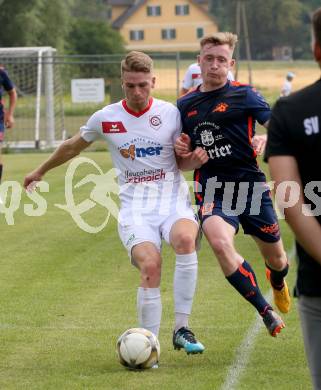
{"left": 116, "top": 328, "right": 160, "bottom": 370}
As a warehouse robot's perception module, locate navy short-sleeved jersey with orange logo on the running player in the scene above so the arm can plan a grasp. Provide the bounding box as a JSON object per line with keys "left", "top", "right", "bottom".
{"left": 177, "top": 82, "right": 270, "bottom": 182}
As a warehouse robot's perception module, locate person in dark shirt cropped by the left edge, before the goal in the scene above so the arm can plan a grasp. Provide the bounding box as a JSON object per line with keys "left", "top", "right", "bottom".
{"left": 0, "top": 64, "right": 17, "bottom": 182}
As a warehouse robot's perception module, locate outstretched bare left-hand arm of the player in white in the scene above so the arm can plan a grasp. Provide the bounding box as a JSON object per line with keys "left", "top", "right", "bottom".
{"left": 23, "top": 133, "right": 91, "bottom": 190}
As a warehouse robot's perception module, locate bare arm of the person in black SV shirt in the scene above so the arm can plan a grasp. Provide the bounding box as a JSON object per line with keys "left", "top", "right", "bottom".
{"left": 269, "top": 156, "right": 321, "bottom": 264}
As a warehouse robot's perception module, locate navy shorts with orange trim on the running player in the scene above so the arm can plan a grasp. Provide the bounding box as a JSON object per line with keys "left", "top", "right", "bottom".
{"left": 196, "top": 183, "right": 280, "bottom": 243}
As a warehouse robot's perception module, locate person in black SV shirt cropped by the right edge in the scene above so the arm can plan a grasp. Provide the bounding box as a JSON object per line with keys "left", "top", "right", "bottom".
{"left": 266, "top": 8, "right": 321, "bottom": 390}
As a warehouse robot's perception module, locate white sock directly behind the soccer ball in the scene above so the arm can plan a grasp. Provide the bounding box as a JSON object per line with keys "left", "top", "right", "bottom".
{"left": 137, "top": 287, "right": 162, "bottom": 336}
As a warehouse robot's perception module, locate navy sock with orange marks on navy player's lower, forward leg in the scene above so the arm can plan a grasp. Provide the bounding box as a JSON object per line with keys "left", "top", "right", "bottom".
{"left": 226, "top": 260, "right": 272, "bottom": 315}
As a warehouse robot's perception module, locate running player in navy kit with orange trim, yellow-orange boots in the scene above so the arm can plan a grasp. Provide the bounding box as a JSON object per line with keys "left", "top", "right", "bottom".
{"left": 175, "top": 33, "right": 290, "bottom": 336}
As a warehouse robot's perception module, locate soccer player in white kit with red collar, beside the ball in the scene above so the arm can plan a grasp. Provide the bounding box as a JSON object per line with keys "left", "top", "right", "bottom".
{"left": 24, "top": 51, "right": 204, "bottom": 354}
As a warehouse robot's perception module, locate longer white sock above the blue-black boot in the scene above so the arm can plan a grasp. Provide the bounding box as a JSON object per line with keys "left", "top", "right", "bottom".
{"left": 174, "top": 252, "right": 198, "bottom": 331}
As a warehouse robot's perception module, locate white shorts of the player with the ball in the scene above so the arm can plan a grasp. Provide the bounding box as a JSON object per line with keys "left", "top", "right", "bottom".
{"left": 118, "top": 208, "right": 198, "bottom": 258}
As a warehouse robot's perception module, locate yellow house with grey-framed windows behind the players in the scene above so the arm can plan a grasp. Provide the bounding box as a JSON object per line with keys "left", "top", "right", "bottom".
{"left": 108, "top": 0, "right": 218, "bottom": 52}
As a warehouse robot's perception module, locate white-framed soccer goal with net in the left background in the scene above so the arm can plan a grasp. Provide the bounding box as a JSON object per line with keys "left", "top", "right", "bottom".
{"left": 0, "top": 47, "right": 65, "bottom": 149}
